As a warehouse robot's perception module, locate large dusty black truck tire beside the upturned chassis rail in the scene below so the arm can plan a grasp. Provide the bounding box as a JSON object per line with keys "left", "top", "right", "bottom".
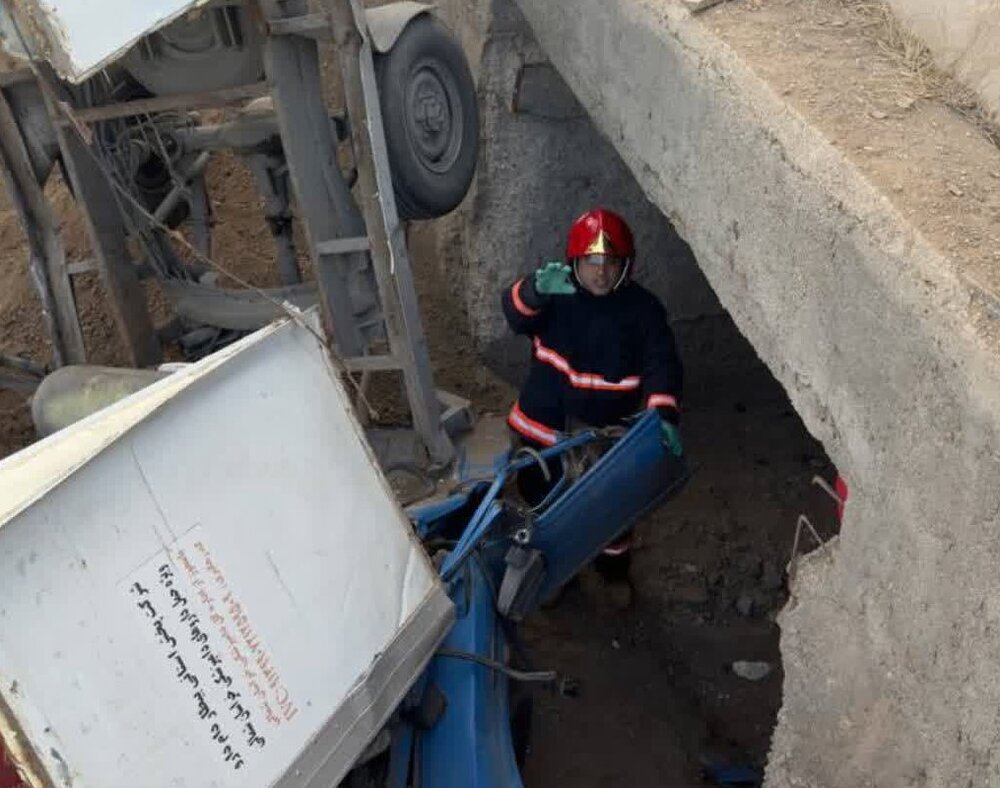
{"left": 375, "top": 14, "right": 479, "bottom": 219}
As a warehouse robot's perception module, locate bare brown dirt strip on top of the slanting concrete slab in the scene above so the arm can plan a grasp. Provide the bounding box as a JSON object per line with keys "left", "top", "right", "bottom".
{"left": 699, "top": 0, "right": 1000, "bottom": 326}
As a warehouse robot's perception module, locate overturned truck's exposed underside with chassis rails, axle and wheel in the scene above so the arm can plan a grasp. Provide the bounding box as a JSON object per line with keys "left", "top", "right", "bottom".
{"left": 0, "top": 0, "right": 478, "bottom": 461}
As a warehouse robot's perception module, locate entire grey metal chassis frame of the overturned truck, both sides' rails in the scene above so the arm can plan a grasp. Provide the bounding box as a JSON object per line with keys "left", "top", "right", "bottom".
{"left": 0, "top": 0, "right": 460, "bottom": 464}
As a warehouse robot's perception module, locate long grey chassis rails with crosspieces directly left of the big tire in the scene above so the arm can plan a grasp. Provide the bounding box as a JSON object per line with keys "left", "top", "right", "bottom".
{"left": 261, "top": 0, "right": 454, "bottom": 463}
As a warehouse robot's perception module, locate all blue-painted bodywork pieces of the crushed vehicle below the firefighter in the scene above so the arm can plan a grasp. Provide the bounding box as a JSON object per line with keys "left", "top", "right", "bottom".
{"left": 391, "top": 413, "right": 687, "bottom": 788}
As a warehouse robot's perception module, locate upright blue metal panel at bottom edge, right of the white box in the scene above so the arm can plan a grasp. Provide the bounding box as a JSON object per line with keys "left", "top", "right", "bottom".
{"left": 418, "top": 560, "right": 522, "bottom": 788}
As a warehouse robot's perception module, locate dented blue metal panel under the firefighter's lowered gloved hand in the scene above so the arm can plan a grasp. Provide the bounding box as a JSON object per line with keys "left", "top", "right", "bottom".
{"left": 531, "top": 411, "right": 688, "bottom": 601}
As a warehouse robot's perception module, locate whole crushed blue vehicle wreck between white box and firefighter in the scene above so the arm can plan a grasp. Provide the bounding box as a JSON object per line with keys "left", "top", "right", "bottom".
{"left": 346, "top": 413, "right": 689, "bottom": 788}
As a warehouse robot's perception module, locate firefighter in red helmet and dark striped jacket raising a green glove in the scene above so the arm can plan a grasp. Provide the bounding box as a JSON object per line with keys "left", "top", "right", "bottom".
{"left": 502, "top": 208, "right": 683, "bottom": 592}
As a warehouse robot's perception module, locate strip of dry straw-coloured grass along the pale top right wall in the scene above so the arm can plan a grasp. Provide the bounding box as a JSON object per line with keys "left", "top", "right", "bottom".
{"left": 839, "top": 0, "right": 1000, "bottom": 148}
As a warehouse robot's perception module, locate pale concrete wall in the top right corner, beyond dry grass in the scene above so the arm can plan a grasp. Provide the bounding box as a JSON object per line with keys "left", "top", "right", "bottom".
{"left": 887, "top": 0, "right": 1000, "bottom": 118}
